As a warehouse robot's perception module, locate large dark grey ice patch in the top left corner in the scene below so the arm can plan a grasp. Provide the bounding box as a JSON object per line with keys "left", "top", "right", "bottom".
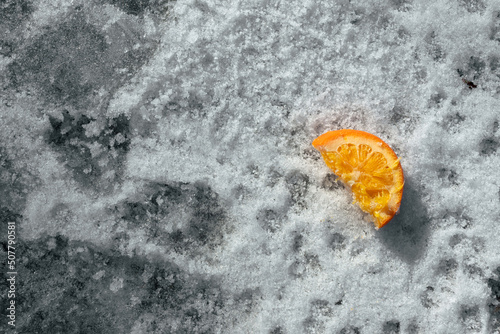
{"left": 8, "top": 9, "right": 152, "bottom": 110}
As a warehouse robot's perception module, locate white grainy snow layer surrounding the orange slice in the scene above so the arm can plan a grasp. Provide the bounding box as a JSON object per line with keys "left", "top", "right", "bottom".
{"left": 1, "top": 0, "right": 500, "bottom": 334}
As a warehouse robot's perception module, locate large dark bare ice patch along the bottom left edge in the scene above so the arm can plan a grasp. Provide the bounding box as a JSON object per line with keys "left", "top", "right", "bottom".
{"left": 16, "top": 236, "right": 230, "bottom": 334}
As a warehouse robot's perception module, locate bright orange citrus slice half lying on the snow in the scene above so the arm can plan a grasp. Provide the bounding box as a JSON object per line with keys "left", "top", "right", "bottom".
{"left": 312, "top": 129, "right": 404, "bottom": 228}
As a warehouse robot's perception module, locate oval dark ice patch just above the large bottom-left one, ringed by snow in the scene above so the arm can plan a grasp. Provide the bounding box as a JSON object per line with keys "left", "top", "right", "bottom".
{"left": 117, "top": 182, "right": 228, "bottom": 253}
